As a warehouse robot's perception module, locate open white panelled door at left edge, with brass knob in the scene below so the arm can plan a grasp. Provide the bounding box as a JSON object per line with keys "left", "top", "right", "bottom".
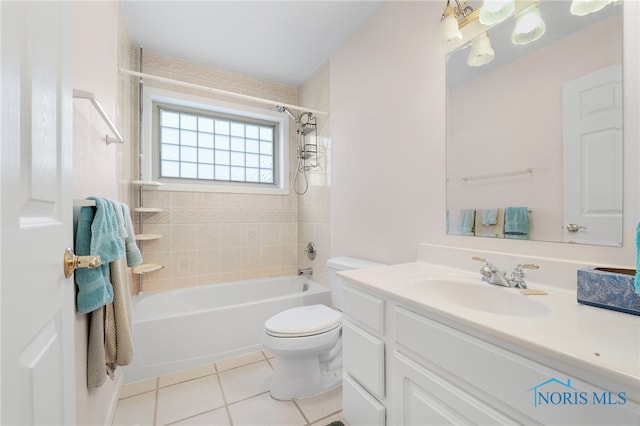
{"left": 0, "top": 1, "right": 76, "bottom": 425}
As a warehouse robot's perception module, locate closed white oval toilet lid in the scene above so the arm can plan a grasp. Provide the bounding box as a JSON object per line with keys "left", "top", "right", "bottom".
{"left": 264, "top": 305, "right": 342, "bottom": 337}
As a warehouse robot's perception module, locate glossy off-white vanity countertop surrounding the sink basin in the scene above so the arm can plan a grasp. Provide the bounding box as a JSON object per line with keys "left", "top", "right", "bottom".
{"left": 339, "top": 262, "right": 640, "bottom": 389}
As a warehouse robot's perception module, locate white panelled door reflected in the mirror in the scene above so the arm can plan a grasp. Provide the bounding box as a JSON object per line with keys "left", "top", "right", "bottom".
{"left": 562, "top": 65, "right": 622, "bottom": 246}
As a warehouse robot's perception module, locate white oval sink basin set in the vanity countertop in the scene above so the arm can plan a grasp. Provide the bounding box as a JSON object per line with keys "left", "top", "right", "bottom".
{"left": 411, "top": 277, "right": 551, "bottom": 317}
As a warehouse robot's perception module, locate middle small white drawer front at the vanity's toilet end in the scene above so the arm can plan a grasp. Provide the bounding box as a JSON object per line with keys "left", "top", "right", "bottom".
{"left": 342, "top": 322, "right": 385, "bottom": 398}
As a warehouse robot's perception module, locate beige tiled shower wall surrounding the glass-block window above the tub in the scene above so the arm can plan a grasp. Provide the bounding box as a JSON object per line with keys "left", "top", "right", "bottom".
{"left": 129, "top": 49, "right": 328, "bottom": 292}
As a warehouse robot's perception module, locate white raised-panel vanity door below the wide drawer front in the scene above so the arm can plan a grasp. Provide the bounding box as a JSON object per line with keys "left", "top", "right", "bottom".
{"left": 392, "top": 352, "right": 516, "bottom": 426}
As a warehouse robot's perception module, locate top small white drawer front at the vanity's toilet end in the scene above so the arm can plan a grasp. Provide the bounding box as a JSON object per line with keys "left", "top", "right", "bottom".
{"left": 343, "top": 283, "right": 385, "bottom": 335}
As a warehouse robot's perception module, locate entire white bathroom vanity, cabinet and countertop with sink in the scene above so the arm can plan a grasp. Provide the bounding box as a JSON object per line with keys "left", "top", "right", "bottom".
{"left": 340, "top": 248, "right": 640, "bottom": 426}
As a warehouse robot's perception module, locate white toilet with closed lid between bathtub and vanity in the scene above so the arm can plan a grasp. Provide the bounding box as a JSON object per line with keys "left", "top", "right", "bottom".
{"left": 262, "top": 257, "right": 381, "bottom": 400}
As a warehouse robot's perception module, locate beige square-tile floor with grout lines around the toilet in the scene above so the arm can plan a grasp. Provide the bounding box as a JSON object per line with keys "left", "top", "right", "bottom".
{"left": 113, "top": 351, "right": 344, "bottom": 426}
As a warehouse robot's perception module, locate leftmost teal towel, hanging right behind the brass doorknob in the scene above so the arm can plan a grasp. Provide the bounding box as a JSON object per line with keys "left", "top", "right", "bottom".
{"left": 75, "top": 207, "right": 113, "bottom": 314}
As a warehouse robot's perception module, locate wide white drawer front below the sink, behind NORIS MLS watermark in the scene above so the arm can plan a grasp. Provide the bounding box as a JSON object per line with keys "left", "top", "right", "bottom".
{"left": 395, "top": 307, "right": 640, "bottom": 425}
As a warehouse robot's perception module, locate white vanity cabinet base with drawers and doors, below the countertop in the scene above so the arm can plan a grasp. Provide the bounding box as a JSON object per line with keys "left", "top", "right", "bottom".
{"left": 343, "top": 281, "right": 640, "bottom": 426}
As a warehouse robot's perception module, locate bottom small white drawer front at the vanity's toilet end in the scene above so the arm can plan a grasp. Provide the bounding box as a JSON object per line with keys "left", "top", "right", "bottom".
{"left": 342, "top": 374, "right": 385, "bottom": 426}
